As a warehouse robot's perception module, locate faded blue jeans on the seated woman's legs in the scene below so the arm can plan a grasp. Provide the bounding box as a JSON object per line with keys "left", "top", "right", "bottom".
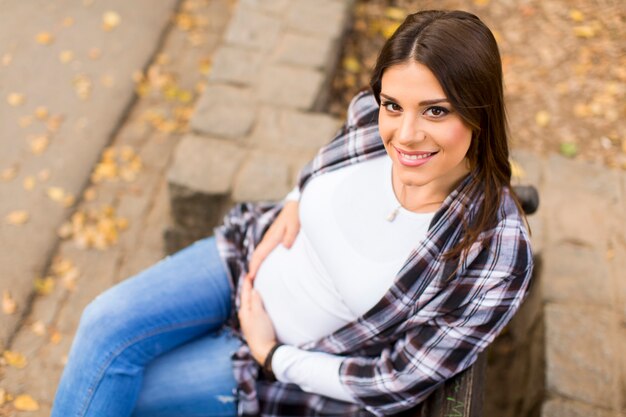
{"left": 51, "top": 238, "right": 241, "bottom": 417}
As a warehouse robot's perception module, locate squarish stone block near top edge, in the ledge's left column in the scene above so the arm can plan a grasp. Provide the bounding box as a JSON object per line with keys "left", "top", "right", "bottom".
{"left": 225, "top": 4, "right": 283, "bottom": 51}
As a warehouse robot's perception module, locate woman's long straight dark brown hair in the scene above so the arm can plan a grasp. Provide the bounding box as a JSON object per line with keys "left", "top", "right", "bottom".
{"left": 370, "top": 10, "right": 521, "bottom": 259}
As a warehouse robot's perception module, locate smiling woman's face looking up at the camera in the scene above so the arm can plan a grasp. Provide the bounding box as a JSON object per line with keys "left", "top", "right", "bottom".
{"left": 379, "top": 61, "right": 472, "bottom": 196}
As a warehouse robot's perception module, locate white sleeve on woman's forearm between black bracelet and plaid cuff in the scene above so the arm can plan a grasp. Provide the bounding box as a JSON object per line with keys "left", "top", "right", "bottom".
{"left": 272, "top": 345, "right": 356, "bottom": 403}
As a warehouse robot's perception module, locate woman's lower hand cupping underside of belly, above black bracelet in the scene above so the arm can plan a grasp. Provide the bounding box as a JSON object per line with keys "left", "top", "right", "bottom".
{"left": 239, "top": 277, "right": 276, "bottom": 365}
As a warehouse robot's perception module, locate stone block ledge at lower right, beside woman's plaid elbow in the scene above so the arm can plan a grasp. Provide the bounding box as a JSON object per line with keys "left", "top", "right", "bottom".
{"left": 487, "top": 151, "right": 626, "bottom": 417}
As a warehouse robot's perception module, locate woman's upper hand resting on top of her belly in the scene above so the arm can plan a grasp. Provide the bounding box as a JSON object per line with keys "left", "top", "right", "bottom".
{"left": 247, "top": 201, "right": 300, "bottom": 280}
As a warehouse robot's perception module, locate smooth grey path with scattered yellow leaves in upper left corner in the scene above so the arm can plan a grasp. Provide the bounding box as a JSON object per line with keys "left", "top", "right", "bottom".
{"left": 0, "top": 0, "right": 177, "bottom": 348}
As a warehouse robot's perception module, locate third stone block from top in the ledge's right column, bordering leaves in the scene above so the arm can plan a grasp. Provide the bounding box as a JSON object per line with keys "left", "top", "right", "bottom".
{"left": 258, "top": 65, "right": 324, "bottom": 110}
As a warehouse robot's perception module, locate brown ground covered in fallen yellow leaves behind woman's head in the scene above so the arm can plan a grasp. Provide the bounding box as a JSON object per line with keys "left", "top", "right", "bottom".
{"left": 331, "top": 0, "right": 626, "bottom": 169}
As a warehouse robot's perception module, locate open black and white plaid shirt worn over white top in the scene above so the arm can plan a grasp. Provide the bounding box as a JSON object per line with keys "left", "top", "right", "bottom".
{"left": 216, "top": 92, "right": 532, "bottom": 416}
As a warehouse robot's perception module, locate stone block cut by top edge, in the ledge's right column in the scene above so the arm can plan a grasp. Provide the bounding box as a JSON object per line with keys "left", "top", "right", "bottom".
{"left": 287, "top": 0, "right": 351, "bottom": 38}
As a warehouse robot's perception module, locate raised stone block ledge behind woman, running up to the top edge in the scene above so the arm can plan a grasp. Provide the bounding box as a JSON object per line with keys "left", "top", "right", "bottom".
{"left": 166, "top": 0, "right": 352, "bottom": 252}
